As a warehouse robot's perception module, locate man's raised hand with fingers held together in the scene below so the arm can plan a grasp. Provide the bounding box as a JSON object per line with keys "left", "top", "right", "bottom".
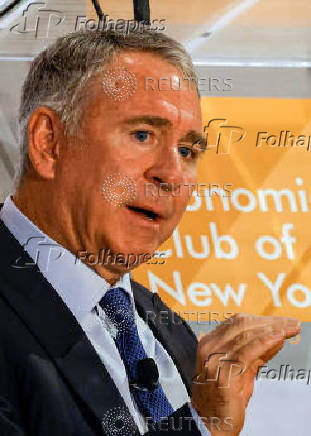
{"left": 192, "top": 314, "right": 301, "bottom": 434}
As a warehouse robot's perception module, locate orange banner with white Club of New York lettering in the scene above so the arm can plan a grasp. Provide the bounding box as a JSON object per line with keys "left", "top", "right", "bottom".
{"left": 133, "top": 97, "right": 311, "bottom": 322}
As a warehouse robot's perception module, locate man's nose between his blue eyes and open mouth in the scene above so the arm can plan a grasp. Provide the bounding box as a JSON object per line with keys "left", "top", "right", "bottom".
{"left": 145, "top": 147, "right": 188, "bottom": 192}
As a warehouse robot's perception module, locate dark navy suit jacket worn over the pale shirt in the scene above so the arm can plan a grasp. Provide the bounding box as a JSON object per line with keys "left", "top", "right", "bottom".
{"left": 0, "top": 215, "right": 200, "bottom": 436}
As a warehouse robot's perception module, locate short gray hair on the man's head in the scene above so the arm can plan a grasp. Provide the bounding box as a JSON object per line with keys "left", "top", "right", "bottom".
{"left": 15, "top": 30, "right": 199, "bottom": 186}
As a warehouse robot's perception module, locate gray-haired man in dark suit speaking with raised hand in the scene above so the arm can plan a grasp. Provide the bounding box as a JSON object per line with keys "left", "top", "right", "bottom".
{"left": 0, "top": 31, "right": 300, "bottom": 436}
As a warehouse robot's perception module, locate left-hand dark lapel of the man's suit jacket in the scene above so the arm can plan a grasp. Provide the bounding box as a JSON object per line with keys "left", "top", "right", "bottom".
{"left": 0, "top": 220, "right": 136, "bottom": 434}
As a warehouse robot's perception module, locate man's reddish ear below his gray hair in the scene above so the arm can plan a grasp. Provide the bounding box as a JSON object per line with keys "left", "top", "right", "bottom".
{"left": 28, "top": 106, "right": 64, "bottom": 179}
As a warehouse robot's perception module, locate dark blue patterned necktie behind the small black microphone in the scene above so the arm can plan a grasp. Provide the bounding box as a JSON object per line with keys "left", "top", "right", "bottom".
{"left": 99, "top": 288, "right": 174, "bottom": 422}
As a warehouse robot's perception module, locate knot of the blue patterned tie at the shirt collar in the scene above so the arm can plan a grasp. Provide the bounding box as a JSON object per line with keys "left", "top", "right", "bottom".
{"left": 99, "top": 288, "right": 135, "bottom": 333}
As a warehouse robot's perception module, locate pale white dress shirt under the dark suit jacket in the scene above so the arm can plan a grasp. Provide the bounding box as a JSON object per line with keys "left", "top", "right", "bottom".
{"left": 0, "top": 196, "right": 209, "bottom": 436}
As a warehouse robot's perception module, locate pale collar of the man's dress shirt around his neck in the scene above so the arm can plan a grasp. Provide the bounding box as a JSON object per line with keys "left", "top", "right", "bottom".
{"left": 0, "top": 196, "right": 133, "bottom": 323}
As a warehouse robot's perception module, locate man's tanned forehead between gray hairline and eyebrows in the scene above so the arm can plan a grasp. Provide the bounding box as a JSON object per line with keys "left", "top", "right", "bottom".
{"left": 85, "top": 51, "right": 201, "bottom": 130}
